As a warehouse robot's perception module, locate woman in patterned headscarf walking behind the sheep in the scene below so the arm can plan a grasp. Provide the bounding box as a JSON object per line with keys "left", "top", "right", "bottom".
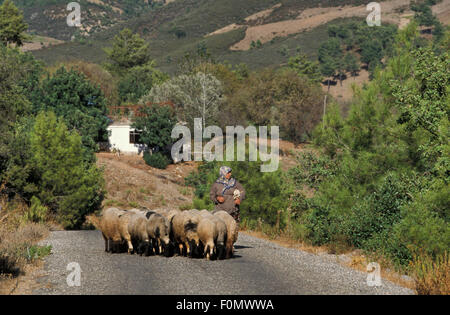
{"left": 209, "top": 166, "right": 245, "bottom": 223}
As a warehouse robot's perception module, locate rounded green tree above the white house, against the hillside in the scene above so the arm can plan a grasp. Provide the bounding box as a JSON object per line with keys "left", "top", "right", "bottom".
{"left": 105, "top": 28, "right": 151, "bottom": 74}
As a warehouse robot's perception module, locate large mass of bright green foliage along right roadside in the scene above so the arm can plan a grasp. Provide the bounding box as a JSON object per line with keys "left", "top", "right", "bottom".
{"left": 290, "top": 24, "right": 450, "bottom": 266}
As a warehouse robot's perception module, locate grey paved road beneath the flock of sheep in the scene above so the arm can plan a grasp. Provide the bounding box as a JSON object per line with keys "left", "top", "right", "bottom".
{"left": 34, "top": 231, "right": 413, "bottom": 294}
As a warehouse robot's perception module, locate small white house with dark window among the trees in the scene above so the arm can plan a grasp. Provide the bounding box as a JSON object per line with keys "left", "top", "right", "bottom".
{"left": 107, "top": 120, "right": 146, "bottom": 154}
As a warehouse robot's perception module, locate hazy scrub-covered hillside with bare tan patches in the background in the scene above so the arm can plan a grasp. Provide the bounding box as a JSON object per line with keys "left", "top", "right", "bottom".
{"left": 30, "top": 0, "right": 450, "bottom": 72}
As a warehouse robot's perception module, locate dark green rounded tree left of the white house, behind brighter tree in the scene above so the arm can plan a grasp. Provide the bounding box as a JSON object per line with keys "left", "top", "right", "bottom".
{"left": 34, "top": 66, "right": 108, "bottom": 154}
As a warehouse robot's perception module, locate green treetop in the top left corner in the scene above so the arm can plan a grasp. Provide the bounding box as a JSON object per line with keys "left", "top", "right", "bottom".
{"left": 0, "top": 0, "right": 28, "bottom": 46}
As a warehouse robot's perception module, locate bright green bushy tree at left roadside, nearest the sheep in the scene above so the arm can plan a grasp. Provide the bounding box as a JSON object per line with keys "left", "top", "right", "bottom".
{"left": 28, "top": 112, "right": 104, "bottom": 228}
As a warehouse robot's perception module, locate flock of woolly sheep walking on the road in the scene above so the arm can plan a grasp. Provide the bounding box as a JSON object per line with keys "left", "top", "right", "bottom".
{"left": 99, "top": 208, "right": 238, "bottom": 260}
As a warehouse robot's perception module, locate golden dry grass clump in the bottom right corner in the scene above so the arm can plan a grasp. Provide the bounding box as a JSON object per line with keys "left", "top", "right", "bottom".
{"left": 411, "top": 253, "right": 450, "bottom": 295}
